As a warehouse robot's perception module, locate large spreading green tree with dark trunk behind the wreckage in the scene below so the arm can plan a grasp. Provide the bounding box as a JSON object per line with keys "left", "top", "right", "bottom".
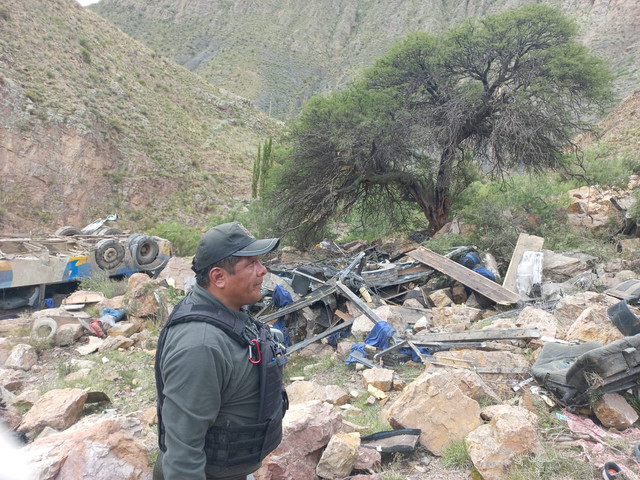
{"left": 278, "top": 5, "right": 610, "bottom": 242}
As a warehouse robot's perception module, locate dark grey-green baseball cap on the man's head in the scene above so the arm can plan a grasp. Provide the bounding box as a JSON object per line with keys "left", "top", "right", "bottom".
{"left": 191, "top": 222, "right": 280, "bottom": 272}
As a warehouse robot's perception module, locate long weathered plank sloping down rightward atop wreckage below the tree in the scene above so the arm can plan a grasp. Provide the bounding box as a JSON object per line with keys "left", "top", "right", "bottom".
{"left": 408, "top": 247, "right": 520, "bottom": 305}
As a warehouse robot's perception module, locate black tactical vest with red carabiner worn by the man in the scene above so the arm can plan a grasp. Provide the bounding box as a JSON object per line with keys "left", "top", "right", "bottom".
{"left": 155, "top": 303, "right": 289, "bottom": 467}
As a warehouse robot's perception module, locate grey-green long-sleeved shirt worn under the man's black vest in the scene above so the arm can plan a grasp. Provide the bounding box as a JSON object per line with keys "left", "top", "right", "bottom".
{"left": 158, "top": 285, "right": 260, "bottom": 480}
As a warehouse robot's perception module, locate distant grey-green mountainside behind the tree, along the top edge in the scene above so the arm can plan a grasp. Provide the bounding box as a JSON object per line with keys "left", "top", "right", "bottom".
{"left": 90, "top": 0, "right": 640, "bottom": 117}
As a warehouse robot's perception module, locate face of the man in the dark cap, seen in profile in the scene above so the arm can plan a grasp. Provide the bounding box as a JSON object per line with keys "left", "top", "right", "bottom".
{"left": 225, "top": 256, "right": 267, "bottom": 310}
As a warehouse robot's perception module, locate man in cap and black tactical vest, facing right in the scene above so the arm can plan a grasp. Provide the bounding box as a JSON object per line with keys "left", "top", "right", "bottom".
{"left": 153, "top": 222, "right": 287, "bottom": 480}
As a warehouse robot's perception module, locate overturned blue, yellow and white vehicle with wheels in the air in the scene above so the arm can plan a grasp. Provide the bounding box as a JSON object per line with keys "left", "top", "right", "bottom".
{"left": 0, "top": 216, "right": 171, "bottom": 310}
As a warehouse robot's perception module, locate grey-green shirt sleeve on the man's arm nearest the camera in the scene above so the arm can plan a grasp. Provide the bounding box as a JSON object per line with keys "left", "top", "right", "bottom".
{"left": 162, "top": 345, "right": 230, "bottom": 480}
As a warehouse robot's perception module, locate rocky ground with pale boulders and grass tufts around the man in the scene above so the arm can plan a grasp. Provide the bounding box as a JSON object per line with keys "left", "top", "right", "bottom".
{"left": 6, "top": 177, "right": 640, "bottom": 480}
